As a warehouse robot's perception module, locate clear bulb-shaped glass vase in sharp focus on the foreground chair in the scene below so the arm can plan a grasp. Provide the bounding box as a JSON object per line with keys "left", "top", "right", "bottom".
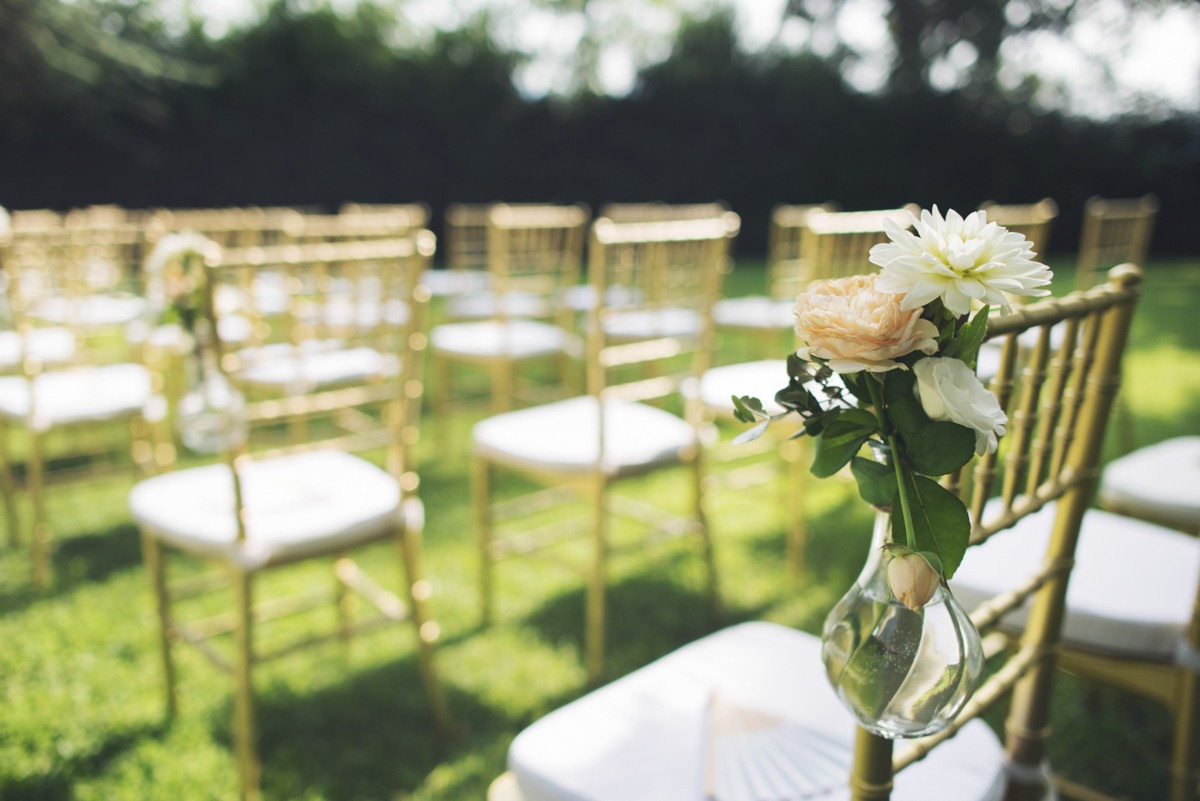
{"left": 821, "top": 512, "right": 983, "bottom": 739}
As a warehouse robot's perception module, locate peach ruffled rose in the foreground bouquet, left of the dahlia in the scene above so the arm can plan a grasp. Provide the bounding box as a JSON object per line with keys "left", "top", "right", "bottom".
{"left": 793, "top": 275, "right": 937, "bottom": 373}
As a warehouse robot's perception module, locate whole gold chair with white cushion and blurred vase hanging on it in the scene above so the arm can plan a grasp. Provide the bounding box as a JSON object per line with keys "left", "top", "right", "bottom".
{"left": 130, "top": 231, "right": 449, "bottom": 799}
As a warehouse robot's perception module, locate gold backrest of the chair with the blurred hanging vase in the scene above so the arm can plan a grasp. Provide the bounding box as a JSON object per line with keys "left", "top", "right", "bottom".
{"left": 199, "top": 230, "right": 434, "bottom": 501}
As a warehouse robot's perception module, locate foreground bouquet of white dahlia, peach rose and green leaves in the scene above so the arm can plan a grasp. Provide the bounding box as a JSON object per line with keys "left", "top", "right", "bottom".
{"left": 733, "top": 206, "right": 1051, "bottom": 610}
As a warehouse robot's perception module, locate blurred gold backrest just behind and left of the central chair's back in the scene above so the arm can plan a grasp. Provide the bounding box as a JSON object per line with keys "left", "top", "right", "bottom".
{"left": 487, "top": 203, "right": 588, "bottom": 329}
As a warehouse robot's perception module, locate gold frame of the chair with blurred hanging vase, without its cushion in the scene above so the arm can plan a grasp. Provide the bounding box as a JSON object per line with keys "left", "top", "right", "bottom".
{"left": 142, "top": 230, "right": 450, "bottom": 800}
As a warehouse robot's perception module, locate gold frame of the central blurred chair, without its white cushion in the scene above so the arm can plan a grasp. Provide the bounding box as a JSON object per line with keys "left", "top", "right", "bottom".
{"left": 472, "top": 212, "right": 740, "bottom": 681}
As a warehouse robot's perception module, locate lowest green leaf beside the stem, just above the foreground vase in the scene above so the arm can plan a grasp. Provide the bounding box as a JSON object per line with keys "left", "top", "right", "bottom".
{"left": 892, "top": 474, "right": 971, "bottom": 579}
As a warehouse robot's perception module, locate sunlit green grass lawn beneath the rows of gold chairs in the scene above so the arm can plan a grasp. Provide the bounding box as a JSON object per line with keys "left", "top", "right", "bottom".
{"left": 0, "top": 255, "right": 1200, "bottom": 801}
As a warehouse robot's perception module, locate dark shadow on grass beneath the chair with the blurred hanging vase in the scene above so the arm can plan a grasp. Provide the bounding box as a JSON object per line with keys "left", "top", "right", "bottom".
{"left": 253, "top": 660, "right": 496, "bottom": 800}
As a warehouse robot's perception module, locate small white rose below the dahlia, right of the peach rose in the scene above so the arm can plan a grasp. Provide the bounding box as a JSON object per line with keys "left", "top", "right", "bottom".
{"left": 912, "top": 356, "right": 1008, "bottom": 456}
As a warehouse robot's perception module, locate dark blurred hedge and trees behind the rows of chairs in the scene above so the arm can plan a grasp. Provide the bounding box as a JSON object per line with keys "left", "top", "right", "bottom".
{"left": 0, "top": 0, "right": 1200, "bottom": 253}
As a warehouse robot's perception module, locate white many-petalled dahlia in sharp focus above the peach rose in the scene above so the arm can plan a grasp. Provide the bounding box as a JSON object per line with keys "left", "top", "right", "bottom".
{"left": 870, "top": 206, "right": 1052, "bottom": 317}
